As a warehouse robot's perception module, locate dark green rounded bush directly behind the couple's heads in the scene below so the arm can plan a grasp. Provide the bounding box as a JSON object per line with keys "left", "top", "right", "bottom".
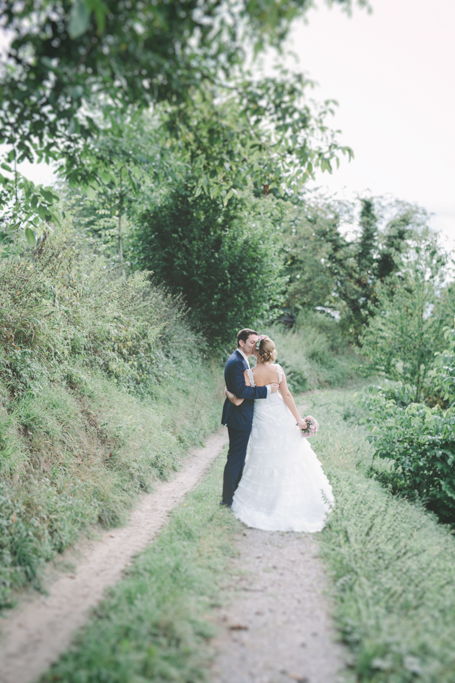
{"left": 133, "top": 183, "right": 284, "bottom": 346}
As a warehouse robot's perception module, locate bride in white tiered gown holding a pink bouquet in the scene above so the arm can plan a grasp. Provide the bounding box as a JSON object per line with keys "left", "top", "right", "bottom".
{"left": 225, "top": 337, "right": 334, "bottom": 533}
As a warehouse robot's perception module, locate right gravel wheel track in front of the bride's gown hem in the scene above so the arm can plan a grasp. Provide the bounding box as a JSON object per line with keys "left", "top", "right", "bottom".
{"left": 210, "top": 529, "right": 343, "bottom": 683}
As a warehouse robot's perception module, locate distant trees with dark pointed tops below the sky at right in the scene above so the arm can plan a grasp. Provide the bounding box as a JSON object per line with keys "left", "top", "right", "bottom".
{"left": 284, "top": 195, "right": 431, "bottom": 343}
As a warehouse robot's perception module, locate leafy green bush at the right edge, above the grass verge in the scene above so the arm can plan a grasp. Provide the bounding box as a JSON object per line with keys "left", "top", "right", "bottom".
{"left": 362, "top": 316, "right": 455, "bottom": 524}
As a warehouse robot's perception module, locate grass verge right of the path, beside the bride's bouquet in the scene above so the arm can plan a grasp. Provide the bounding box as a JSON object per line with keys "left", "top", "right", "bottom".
{"left": 310, "top": 391, "right": 455, "bottom": 683}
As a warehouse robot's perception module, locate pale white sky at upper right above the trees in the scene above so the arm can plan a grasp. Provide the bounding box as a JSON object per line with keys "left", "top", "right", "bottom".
{"left": 288, "top": 0, "right": 455, "bottom": 239}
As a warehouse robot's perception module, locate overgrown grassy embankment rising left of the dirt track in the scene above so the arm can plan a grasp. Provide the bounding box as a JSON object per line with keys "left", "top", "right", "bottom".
{"left": 0, "top": 224, "right": 222, "bottom": 606}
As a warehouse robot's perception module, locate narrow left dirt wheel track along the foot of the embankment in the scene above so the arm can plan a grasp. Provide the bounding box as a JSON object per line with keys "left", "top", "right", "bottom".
{"left": 0, "top": 429, "right": 227, "bottom": 683}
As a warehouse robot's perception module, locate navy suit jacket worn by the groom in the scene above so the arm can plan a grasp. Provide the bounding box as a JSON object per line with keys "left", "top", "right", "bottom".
{"left": 221, "top": 349, "right": 267, "bottom": 432}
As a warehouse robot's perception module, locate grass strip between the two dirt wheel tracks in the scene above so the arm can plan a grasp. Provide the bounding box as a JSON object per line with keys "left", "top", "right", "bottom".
{"left": 41, "top": 454, "right": 239, "bottom": 683}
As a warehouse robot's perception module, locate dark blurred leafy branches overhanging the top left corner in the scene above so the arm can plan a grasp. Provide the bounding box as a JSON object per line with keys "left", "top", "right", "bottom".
{"left": 0, "top": 0, "right": 365, "bottom": 156}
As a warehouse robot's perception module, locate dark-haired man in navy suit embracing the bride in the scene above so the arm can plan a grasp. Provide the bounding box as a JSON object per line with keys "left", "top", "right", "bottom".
{"left": 221, "top": 328, "right": 279, "bottom": 507}
